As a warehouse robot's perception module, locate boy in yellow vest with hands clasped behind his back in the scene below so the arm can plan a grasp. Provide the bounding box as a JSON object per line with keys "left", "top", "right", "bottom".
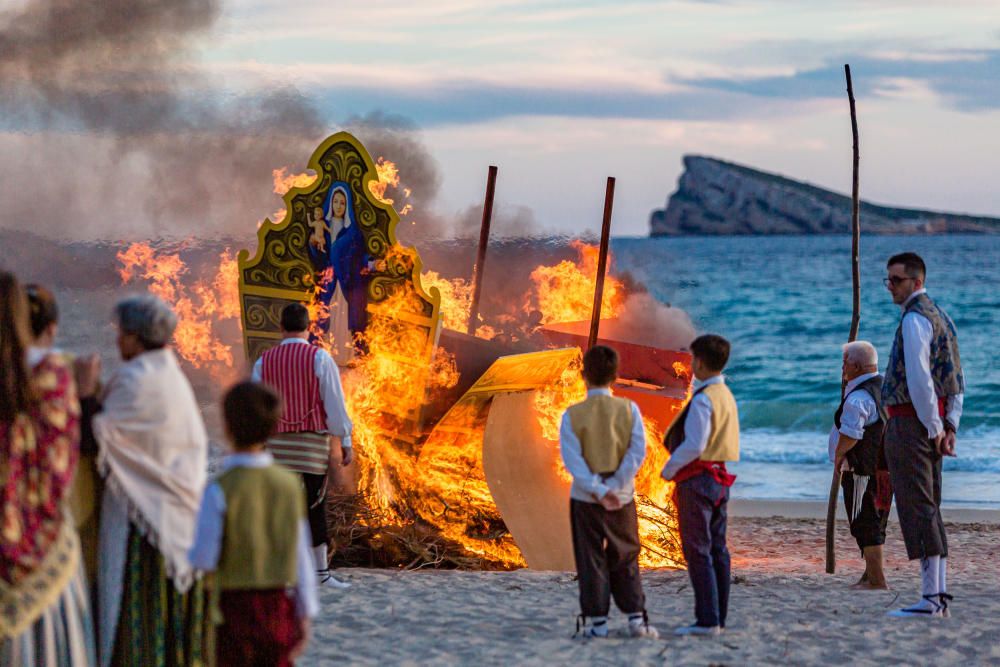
{"left": 559, "top": 345, "right": 659, "bottom": 638}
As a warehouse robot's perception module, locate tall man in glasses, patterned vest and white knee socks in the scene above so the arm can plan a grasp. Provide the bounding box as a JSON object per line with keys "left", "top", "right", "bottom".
{"left": 882, "top": 252, "right": 965, "bottom": 617}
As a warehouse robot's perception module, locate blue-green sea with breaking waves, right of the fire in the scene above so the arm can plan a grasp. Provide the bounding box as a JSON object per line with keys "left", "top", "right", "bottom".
{"left": 612, "top": 235, "right": 1000, "bottom": 508}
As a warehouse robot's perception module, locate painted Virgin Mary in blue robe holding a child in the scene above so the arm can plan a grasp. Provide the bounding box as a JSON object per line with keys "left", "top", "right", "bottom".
{"left": 309, "top": 181, "right": 371, "bottom": 363}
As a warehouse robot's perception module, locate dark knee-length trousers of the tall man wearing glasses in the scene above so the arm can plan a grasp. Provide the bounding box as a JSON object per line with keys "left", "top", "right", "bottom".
{"left": 885, "top": 416, "right": 948, "bottom": 560}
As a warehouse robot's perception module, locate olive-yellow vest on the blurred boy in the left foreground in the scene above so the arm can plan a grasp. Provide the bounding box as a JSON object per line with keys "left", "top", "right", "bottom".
{"left": 216, "top": 465, "right": 306, "bottom": 590}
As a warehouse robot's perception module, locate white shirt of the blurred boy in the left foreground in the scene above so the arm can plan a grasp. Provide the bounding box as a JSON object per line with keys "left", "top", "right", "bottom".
{"left": 188, "top": 452, "right": 319, "bottom": 618}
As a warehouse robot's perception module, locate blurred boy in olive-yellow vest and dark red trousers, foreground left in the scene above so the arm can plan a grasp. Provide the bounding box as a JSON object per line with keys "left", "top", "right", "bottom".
{"left": 189, "top": 382, "right": 319, "bottom": 667}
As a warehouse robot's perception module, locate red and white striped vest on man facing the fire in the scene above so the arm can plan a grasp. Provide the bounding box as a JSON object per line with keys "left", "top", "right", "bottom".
{"left": 261, "top": 343, "right": 326, "bottom": 433}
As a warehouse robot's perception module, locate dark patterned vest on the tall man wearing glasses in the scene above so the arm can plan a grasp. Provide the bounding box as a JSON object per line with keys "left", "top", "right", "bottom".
{"left": 882, "top": 294, "right": 965, "bottom": 406}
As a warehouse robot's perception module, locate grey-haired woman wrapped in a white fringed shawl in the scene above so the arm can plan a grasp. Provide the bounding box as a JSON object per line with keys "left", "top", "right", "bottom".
{"left": 77, "top": 295, "right": 208, "bottom": 665}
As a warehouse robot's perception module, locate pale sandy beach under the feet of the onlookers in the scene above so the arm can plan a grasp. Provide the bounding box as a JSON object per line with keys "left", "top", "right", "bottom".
{"left": 300, "top": 501, "right": 1000, "bottom": 665}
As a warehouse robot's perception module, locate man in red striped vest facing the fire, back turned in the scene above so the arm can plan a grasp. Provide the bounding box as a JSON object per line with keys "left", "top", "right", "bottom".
{"left": 252, "top": 303, "right": 353, "bottom": 588}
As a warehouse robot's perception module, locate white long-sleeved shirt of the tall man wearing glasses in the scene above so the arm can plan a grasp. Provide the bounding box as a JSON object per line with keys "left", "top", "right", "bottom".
{"left": 902, "top": 289, "right": 964, "bottom": 438}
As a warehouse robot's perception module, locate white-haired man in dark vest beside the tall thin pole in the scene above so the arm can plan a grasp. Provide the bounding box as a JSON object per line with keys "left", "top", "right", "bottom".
{"left": 829, "top": 340, "right": 892, "bottom": 589}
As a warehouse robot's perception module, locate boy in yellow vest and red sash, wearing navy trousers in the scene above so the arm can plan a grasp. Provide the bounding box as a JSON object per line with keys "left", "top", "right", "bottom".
{"left": 662, "top": 334, "right": 740, "bottom": 635}
